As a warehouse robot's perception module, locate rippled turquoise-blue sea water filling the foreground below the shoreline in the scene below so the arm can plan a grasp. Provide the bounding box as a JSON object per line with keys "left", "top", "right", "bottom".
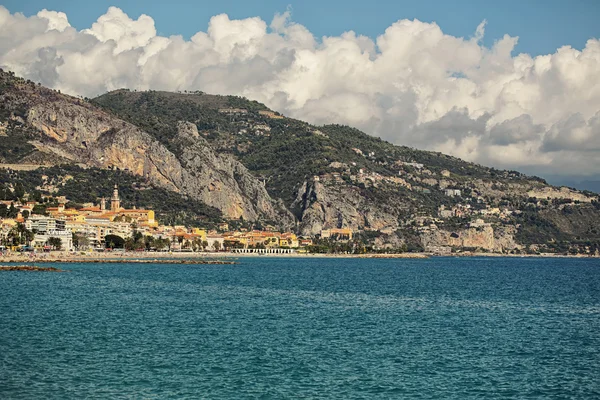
{"left": 0, "top": 258, "right": 600, "bottom": 399}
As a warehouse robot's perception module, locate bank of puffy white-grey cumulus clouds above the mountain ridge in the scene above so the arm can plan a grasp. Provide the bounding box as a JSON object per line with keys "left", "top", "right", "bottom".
{"left": 0, "top": 6, "right": 600, "bottom": 174}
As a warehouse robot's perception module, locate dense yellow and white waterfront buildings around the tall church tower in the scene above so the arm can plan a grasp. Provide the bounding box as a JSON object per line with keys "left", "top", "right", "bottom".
{"left": 0, "top": 185, "right": 353, "bottom": 254}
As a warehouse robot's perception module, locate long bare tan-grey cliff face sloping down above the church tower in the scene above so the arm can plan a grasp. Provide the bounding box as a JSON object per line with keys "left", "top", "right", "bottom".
{"left": 1, "top": 73, "right": 293, "bottom": 226}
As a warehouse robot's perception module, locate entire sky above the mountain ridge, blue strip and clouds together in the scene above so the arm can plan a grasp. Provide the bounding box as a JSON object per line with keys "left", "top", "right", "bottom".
{"left": 0, "top": 0, "right": 600, "bottom": 184}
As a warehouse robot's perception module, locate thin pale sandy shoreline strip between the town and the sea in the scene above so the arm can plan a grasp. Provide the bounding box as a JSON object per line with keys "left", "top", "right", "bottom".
{"left": 0, "top": 251, "right": 598, "bottom": 264}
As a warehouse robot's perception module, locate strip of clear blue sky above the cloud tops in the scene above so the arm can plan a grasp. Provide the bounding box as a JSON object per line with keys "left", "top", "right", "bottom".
{"left": 2, "top": 0, "right": 600, "bottom": 55}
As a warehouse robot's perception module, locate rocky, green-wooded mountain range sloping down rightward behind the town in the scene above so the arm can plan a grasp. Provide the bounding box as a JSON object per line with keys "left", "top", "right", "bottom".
{"left": 0, "top": 67, "right": 600, "bottom": 252}
